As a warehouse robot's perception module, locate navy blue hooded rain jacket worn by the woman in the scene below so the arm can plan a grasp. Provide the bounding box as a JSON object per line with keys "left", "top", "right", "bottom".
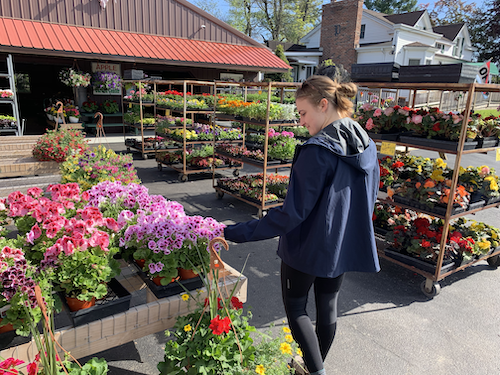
{"left": 224, "top": 118, "right": 380, "bottom": 278}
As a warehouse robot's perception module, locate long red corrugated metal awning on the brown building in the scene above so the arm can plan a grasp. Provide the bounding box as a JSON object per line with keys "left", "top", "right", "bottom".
{"left": 0, "top": 18, "right": 291, "bottom": 71}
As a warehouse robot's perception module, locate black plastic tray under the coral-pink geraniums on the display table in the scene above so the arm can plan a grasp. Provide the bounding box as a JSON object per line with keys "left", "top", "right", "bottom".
{"left": 59, "top": 279, "right": 132, "bottom": 327}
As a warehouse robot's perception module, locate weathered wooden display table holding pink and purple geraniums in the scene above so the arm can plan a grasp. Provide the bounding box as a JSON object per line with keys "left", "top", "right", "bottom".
{"left": 0, "top": 261, "right": 248, "bottom": 362}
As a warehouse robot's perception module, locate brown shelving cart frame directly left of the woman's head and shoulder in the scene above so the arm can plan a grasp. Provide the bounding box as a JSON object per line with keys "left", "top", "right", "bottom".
{"left": 212, "top": 82, "right": 300, "bottom": 218}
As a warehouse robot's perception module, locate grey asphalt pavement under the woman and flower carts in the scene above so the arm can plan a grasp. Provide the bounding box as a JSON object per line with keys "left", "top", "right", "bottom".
{"left": 79, "top": 143, "right": 500, "bottom": 375}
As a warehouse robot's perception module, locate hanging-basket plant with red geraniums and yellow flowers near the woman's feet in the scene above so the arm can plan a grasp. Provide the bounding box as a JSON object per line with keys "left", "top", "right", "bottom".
{"left": 158, "top": 244, "right": 302, "bottom": 375}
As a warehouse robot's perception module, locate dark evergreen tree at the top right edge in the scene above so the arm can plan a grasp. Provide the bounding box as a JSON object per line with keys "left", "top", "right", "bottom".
{"left": 469, "top": 0, "right": 500, "bottom": 63}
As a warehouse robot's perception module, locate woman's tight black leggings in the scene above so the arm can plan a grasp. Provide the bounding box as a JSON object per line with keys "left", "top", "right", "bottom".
{"left": 281, "top": 262, "right": 344, "bottom": 373}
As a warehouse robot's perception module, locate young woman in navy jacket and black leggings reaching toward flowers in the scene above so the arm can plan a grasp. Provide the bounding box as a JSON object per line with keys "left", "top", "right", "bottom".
{"left": 224, "top": 76, "right": 380, "bottom": 374}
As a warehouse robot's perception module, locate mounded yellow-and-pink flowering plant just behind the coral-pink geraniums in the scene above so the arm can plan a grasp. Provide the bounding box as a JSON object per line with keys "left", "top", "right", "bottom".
{"left": 61, "top": 145, "right": 140, "bottom": 190}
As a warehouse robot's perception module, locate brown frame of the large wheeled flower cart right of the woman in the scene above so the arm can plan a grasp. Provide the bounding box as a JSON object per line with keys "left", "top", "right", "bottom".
{"left": 357, "top": 82, "right": 500, "bottom": 297}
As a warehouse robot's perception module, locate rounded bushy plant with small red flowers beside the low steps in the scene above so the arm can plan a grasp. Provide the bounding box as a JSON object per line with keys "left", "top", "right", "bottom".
{"left": 33, "top": 129, "right": 89, "bottom": 163}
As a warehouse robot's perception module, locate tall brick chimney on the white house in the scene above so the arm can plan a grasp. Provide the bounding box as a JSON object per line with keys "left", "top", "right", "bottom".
{"left": 320, "top": 0, "right": 363, "bottom": 72}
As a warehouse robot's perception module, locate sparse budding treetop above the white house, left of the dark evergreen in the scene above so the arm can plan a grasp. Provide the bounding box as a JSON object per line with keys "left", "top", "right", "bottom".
{"left": 429, "top": 0, "right": 478, "bottom": 26}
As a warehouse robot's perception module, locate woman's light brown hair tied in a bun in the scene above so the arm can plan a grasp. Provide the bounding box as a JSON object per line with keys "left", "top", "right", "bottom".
{"left": 295, "top": 76, "right": 358, "bottom": 117}
